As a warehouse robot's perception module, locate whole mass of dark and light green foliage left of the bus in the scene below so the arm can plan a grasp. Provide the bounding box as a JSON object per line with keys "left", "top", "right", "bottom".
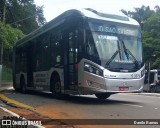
{"left": 0, "top": 0, "right": 46, "bottom": 66}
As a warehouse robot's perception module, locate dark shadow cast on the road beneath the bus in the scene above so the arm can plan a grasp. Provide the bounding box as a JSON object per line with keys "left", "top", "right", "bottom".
{"left": 3, "top": 89, "right": 141, "bottom": 105}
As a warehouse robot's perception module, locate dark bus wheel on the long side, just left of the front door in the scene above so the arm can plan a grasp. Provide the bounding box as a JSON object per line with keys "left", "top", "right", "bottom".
{"left": 51, "top": 76, "right": 61, "bottom": 95}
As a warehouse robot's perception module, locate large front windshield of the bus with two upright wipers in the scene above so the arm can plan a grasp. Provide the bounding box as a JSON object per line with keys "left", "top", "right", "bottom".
{"left": 89, "top": 22, "right": 142, "bottom": 70}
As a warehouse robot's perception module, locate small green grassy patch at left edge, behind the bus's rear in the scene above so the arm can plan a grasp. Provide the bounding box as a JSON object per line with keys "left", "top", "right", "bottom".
{"left": 2, "top": 65, "right": 12, "bottom": 82}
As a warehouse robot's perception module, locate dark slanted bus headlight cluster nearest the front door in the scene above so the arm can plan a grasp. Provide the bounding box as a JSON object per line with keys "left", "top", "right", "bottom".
{"left": 84, "top": 63, "right": 103, "bottom": 76}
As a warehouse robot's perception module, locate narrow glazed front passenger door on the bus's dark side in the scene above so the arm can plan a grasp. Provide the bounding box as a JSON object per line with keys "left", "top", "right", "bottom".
{"left": 66, "top": 30, "right": 78, "bottom": 90}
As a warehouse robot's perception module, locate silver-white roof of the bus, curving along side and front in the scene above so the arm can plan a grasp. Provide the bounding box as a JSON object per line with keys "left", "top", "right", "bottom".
{"left": 15, "top": 8, "right": 139, "bottom": 46}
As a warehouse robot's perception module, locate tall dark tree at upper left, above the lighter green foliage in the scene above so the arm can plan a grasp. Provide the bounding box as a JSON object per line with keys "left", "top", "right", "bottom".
{"left": 0, "top": 0, "right": 46, "bottom": 34}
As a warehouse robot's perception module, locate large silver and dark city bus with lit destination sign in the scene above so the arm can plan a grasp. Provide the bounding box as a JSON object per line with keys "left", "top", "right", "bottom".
{"left": 13, "top": 8, "right": 145, "bottom": 99}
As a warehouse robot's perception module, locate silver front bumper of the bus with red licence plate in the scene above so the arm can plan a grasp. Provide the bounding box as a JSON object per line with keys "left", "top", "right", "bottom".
{"left": 79, "top": 73, "right": 144, "bottom": 94}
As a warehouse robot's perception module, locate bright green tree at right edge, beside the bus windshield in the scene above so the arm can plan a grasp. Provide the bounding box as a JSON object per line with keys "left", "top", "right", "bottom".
{"left": 143, "top": 13, "right": 160, "bottom": 68}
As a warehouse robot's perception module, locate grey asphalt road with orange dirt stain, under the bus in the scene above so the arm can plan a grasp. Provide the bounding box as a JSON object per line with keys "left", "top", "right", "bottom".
{"left": 0, "top": 90, "right": 160, "bottom": 128}
